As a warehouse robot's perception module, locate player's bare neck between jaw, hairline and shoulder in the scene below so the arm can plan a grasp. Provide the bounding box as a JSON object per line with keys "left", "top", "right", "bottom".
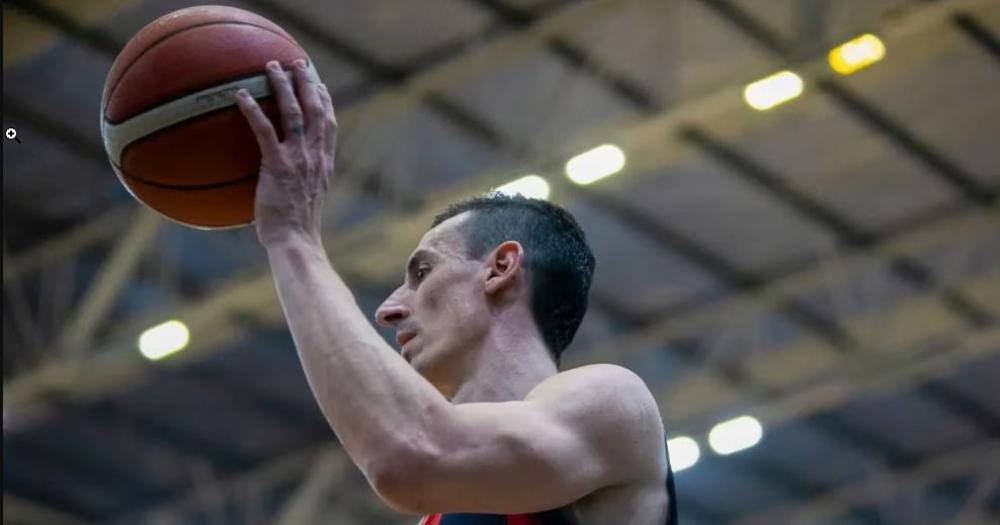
{"left": 451, "top": 334, "right": 559, "bottom": 404}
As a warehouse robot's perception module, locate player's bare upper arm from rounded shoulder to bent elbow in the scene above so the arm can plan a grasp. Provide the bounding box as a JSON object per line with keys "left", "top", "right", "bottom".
{"left": 372, "top": 365, "right": 663, "bottom": 514}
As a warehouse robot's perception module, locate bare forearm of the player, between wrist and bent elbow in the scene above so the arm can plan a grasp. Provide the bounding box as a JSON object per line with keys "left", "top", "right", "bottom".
{"left": 268, "top": 242, "right": 450, "bottom": 469}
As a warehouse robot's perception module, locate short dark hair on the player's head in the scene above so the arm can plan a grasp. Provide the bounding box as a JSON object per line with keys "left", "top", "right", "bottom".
{"left": 431, "top": 192, "right": 594, "bottom": 363}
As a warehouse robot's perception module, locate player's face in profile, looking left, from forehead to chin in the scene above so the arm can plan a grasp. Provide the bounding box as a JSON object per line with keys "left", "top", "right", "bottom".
{"left": 376, "top": 215, "right": 490, "bottom": 391}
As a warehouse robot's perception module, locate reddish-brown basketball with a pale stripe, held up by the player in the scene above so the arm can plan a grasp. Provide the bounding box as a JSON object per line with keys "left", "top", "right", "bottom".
{"left": 101, "top": 6, "right": 316, "bottom": 229}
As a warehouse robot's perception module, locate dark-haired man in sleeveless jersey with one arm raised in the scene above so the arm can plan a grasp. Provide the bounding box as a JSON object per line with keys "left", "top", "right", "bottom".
{"left": 237, "top": 62, "right": 676, "bottom": 525}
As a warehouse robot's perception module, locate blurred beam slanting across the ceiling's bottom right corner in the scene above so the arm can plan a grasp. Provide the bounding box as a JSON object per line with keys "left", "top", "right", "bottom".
{"left": 733, "top": 441, "right": 1000, "bottom": 525}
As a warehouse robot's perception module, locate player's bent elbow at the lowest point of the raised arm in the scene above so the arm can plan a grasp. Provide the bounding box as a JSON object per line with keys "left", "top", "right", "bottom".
{"left": 366, "top": 438, "right": 436, "bottom": 514}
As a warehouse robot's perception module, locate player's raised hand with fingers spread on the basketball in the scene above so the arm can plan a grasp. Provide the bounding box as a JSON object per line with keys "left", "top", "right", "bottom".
{"left": 236, "top": 60, "right": 337, "bottom": 248}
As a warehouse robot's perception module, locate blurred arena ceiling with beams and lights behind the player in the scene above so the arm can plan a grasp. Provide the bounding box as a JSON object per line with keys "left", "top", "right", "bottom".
{"left": 3, "top": 0, "right": 1000, "bottom": 525}
